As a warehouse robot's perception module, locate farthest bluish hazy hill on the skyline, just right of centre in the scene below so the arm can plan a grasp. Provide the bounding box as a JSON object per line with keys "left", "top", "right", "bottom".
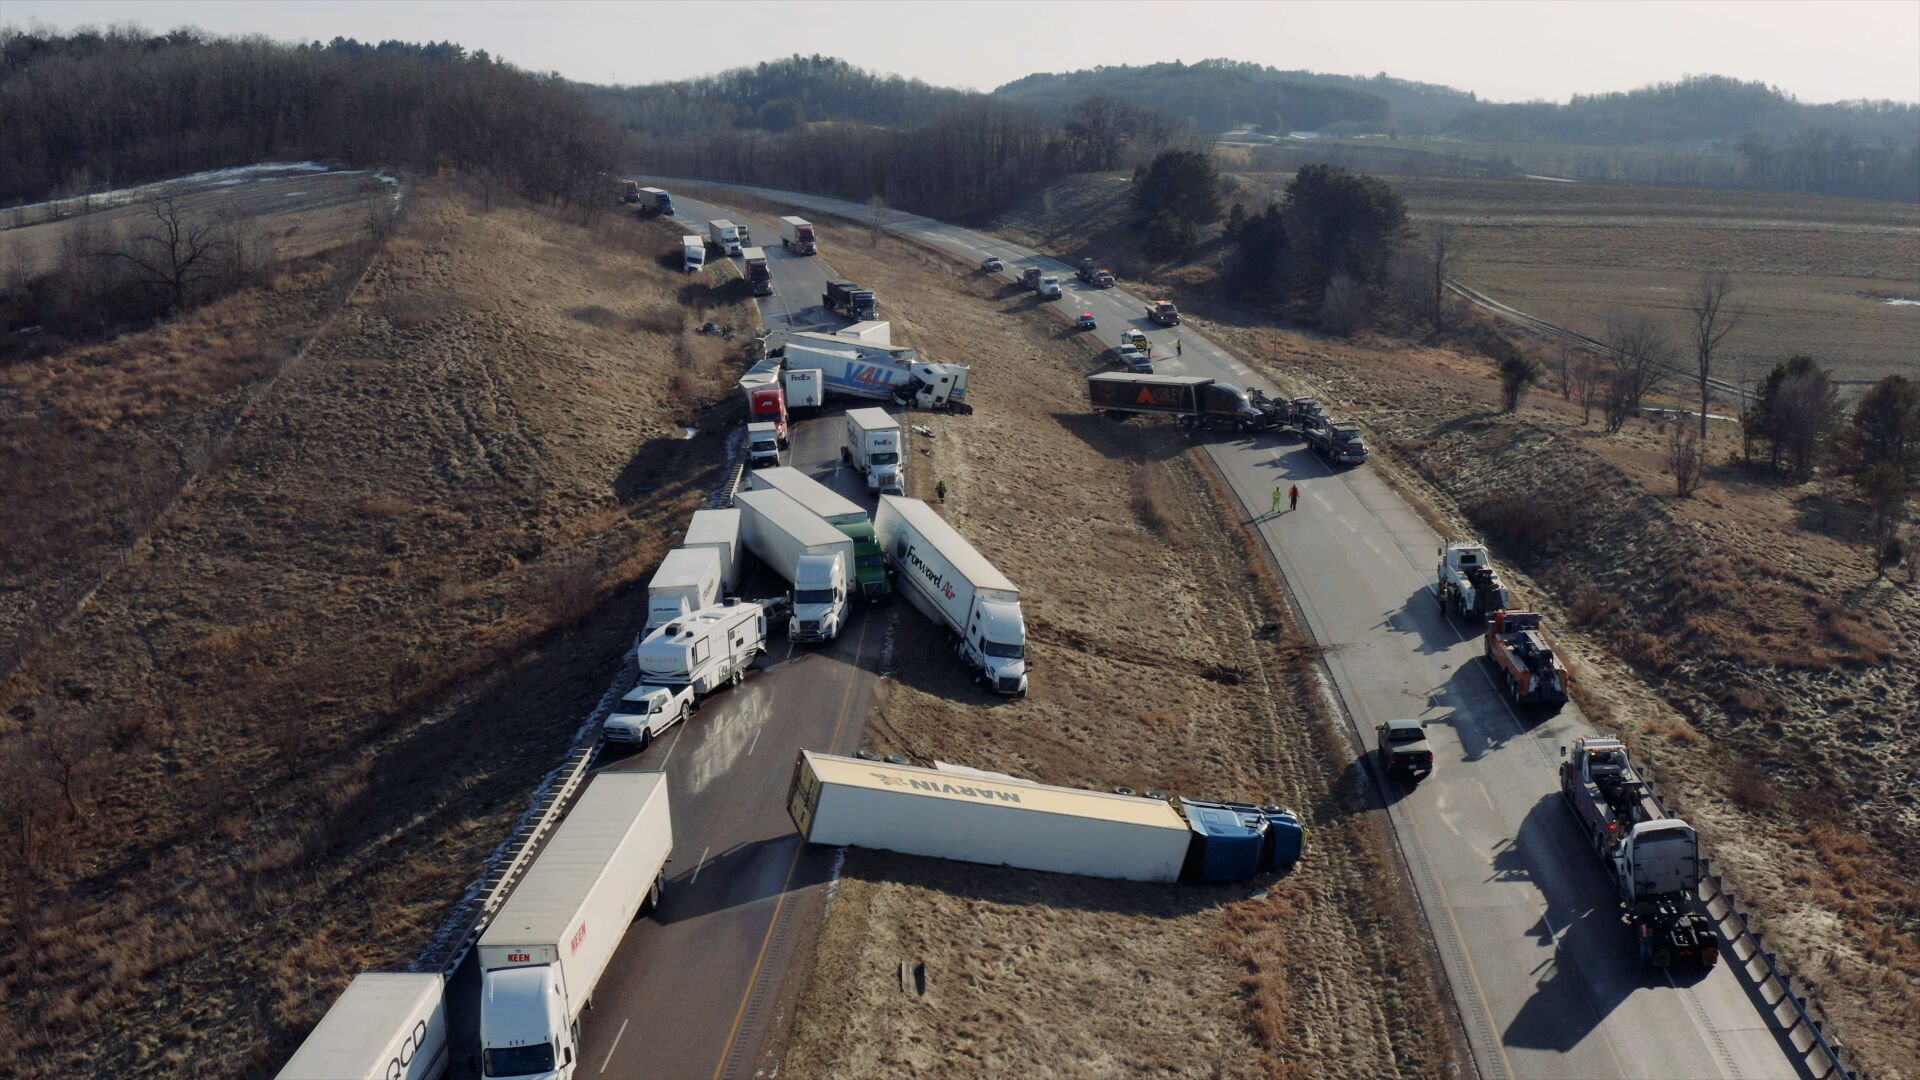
{"left": 993, "top": 60, "right": 1388, "bottom": 133}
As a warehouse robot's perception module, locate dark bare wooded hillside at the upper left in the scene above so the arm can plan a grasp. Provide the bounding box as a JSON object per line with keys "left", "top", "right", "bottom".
{"left": 0, "top": 27, "right": 620, "bottom": 206}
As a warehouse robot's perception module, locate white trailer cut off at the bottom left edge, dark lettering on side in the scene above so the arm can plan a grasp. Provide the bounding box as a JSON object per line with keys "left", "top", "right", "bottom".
{"left": 278, "top": 972, "right": 449, "bottom": 1080}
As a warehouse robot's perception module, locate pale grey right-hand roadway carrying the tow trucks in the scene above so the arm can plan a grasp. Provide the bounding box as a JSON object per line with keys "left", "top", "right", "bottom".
{"left": 649, "top": 181, "right": 1799, "bottom": 1078}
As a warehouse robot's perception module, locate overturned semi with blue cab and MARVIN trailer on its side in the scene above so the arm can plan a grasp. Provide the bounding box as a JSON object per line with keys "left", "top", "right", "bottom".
{"left": 787, "top": 749, "right": 1306, "bottom": 882}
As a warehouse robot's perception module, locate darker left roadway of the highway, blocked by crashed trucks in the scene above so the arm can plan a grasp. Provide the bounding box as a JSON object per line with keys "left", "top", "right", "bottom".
{"left": 449, "top": 196, "right": 883, "bottom": 1080}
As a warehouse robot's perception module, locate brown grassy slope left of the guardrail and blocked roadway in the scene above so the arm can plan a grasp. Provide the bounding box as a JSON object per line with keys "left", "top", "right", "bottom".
{"left": 0, "top": 183, "right": 751, "bottom": 1076}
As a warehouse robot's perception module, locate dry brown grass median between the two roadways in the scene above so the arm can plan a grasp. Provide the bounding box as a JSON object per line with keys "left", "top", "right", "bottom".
{"left": 783, "top": 236, "right": 1457, "bottom": 1076}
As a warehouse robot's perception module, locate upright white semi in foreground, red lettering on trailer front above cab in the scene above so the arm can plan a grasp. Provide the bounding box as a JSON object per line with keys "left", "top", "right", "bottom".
{"left": 476, "top": 773, "right": 674, "bottom": 1078}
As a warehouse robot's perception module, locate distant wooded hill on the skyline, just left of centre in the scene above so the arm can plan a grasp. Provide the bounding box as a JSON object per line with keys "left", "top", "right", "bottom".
{"left": 574, "top": 54, "right": 979, "bottom": 136}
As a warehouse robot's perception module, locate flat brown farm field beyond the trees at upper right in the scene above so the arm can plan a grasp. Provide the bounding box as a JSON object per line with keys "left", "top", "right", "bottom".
{"left": 1235, "top": 175, "right": 1920, "bottom": 386}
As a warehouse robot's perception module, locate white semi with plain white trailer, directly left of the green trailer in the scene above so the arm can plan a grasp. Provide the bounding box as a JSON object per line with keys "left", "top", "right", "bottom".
{"left": 733, "top": 490, "right": 854, "bottom": 642}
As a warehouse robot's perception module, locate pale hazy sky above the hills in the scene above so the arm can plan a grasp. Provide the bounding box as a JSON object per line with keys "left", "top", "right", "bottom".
{"left": 15, "top": 0, "right": 1920, "bottom": 102}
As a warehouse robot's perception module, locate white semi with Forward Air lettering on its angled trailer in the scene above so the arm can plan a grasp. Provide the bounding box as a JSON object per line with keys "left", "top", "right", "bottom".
{"left": 874, "top": 496, "right": 1027, "bottom": 696}
